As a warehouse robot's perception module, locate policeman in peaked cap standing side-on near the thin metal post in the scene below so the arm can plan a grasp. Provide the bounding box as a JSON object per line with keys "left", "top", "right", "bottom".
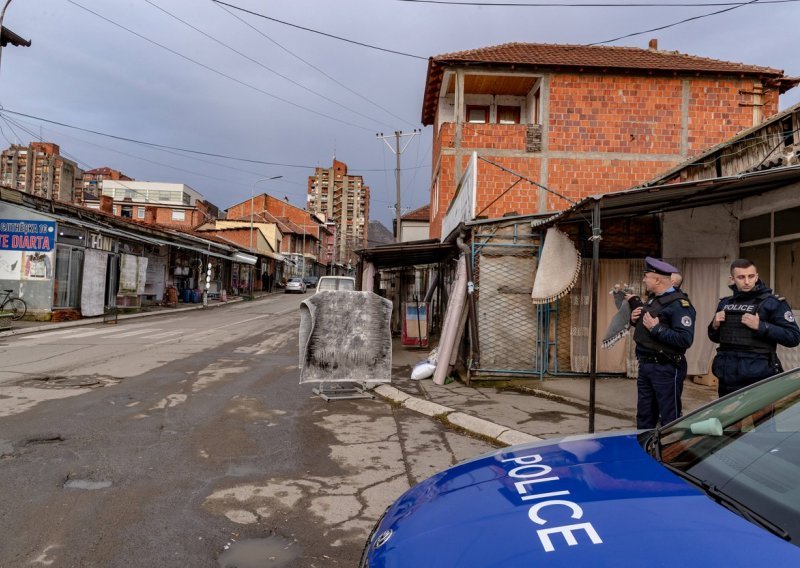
{"left": 631, "top": 256, "right": 696, "bottom": 428}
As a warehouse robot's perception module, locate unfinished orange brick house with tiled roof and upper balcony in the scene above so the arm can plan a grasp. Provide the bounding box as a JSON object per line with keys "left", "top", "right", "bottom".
{"left": 422, "top": 41, "right": 798, "bottom": 237}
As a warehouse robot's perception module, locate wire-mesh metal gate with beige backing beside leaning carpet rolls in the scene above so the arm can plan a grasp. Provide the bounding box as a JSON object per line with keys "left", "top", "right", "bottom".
{"left": 471, "top": 222, "right": 558, "bottom": 378}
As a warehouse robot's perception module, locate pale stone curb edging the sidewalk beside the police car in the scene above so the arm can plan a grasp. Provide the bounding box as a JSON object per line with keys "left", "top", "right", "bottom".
{"left": 373, "top": 384, "right": 542, "bottom": 446}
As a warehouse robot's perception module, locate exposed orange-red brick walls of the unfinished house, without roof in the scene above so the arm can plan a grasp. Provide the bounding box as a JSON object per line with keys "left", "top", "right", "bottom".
{"left": 430, "top": 74, "right": 777, "bottom": 240}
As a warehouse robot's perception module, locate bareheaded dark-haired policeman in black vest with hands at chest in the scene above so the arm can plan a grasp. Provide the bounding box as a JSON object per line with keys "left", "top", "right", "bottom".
{"left": 708, "top": 258, "right": 800, "bottom": 396}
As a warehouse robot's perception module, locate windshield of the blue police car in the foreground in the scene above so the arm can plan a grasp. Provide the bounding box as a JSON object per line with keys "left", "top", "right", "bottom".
{"left": 654, "top": 369, "right": 800, "bottom": 544}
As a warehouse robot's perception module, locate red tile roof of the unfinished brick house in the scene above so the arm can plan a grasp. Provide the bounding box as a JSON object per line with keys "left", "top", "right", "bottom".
{"left": 422, "top": 43, "right": 796, "bottom": 124}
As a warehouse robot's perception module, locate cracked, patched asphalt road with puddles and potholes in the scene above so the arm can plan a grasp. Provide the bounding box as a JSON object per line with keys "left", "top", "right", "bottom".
{"left": 0, "top": 296, "right": 489, "bottom": 568}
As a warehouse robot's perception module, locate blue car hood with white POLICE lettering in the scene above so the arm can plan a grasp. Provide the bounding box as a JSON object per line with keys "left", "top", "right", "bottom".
{"left": 368, "top": 434, "right": 800, "bottom": 568}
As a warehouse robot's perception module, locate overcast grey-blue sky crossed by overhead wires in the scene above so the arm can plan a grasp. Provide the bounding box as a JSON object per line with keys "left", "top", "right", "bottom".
{"left": 0, "top": 0, "right": 800, "bottom": 227}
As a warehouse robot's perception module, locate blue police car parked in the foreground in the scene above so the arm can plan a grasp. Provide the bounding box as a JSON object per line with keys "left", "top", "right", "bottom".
{"left": 361, "top": 369, "right": 800, "bottom": 568}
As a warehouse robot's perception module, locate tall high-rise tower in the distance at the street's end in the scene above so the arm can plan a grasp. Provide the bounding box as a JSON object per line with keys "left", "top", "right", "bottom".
{"left": 308, "top": 158, "right": 369, "bottom": 264}
